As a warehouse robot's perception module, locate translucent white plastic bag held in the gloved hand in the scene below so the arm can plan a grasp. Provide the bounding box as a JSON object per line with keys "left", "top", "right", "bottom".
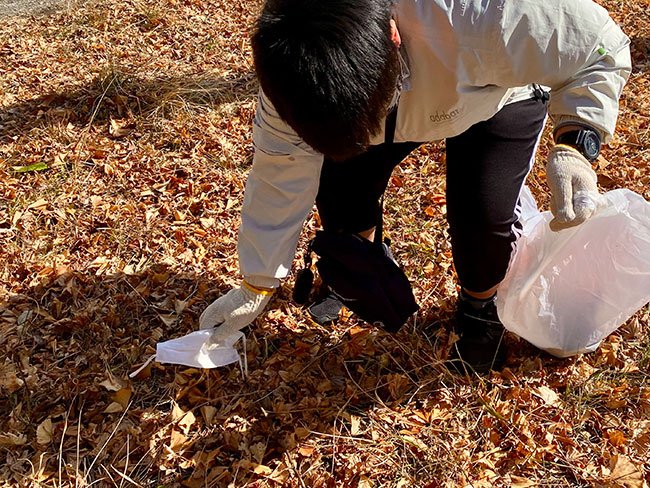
{"left": 497, "top": 188, "right": 650, "bottom": 357}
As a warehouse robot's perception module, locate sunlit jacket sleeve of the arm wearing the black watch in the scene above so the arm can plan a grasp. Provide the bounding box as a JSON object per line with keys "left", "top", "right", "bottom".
{"left": 492, "top": 0, "right": 631, "bottom": 142}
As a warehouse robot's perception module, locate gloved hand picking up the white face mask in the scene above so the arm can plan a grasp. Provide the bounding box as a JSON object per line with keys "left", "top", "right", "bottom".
{"left": 199, "top": 281, "right": 273, "bottom": 342}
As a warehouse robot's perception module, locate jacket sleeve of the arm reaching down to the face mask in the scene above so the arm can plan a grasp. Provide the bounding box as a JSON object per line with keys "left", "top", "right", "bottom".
{"left": 237, "top": 91, "right": 323, "bottom": 287}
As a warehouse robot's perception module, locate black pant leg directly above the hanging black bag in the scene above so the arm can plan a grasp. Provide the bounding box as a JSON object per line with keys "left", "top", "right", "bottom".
{"left": 316, "top": 142, "right": 420, "bottom": 233}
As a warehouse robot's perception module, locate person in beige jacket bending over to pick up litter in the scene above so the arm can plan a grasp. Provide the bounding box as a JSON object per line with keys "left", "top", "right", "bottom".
{"left": 200, "top": 0, "right": 631, "bottom": 372}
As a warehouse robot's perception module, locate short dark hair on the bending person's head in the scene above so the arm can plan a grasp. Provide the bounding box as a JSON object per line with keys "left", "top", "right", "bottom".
{"left": 252, "top": 0, "right": 399, "bottom": 160}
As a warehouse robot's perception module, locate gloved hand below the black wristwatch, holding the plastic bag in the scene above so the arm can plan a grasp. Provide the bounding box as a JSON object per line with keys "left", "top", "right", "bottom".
{"left": 546, "top": 144, "right": 598, "bottom": 231}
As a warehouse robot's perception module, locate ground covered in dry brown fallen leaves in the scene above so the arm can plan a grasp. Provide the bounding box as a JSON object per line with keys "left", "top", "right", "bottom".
{"left": 0, "top": 0, "right": 650, "bottom": 487}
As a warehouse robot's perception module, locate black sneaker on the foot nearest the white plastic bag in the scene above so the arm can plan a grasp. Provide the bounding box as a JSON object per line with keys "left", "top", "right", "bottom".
{"left": 449, "top": 291, "right": 506, "bottom": 374}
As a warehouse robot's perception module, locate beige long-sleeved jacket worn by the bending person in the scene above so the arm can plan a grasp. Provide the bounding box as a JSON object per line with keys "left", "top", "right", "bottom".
{"left": 238, "top": 0, "right": 631, "bottom": 286}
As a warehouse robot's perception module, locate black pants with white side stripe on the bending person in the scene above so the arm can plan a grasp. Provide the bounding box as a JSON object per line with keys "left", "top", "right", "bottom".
{"left": 316, "top": 99, "right": 546, "bottom": 292}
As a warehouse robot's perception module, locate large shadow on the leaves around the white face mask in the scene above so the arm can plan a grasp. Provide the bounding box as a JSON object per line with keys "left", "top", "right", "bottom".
{"left": 0, "top": 265, "right": 446, "bottom": 486}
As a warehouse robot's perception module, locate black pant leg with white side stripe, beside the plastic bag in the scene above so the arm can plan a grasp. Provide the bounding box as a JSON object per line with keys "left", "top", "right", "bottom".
{"left": 447, "top": 99, "right": 546, "bottom": 292}
